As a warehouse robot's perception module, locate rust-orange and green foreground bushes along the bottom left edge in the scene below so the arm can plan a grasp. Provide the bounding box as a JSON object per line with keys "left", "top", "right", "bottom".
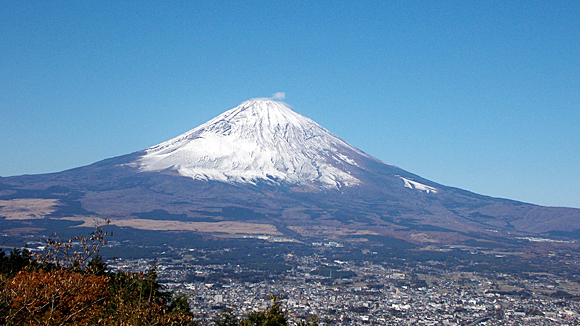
{"left": 0, "top": 223, "right": 318, "bottom": 326}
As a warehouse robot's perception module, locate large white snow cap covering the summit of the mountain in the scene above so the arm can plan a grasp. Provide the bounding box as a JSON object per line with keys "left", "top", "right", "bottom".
{"left": 136, "top": 99, "right": 370, "bottom": 188}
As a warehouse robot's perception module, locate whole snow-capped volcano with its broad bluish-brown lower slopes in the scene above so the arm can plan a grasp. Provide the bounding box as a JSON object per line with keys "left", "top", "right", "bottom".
{"left": 0, "top": 99, "right": 580, "bottom": 243}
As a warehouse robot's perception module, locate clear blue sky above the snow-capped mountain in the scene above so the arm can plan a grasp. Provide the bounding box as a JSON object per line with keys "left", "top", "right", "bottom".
{"left": 0, "top": 0, "right": 580, "bottom": 207}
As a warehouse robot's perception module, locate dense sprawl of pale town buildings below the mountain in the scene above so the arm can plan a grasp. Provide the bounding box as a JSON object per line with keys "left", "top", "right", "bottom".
{"left": 103, "top": 238, "right": 580, "bottom": 325}
